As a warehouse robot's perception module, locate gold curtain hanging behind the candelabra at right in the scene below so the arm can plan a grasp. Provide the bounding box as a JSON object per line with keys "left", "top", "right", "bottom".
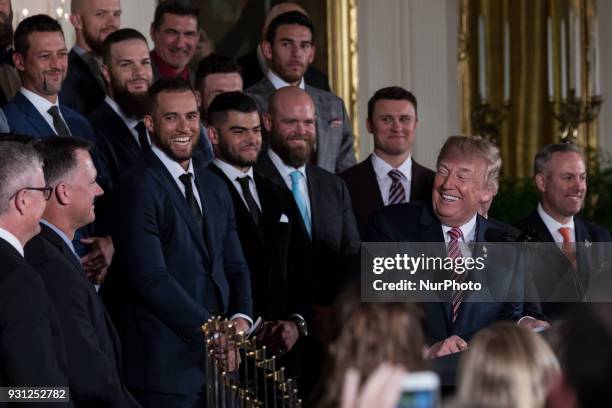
{"left": 458, "top": 0, "right": 597, "bottom": 177}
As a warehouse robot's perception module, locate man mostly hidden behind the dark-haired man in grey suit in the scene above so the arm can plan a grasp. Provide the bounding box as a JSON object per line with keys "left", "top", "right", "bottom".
{"left": 238, "top": 2, "right": 331, "bottom": 92}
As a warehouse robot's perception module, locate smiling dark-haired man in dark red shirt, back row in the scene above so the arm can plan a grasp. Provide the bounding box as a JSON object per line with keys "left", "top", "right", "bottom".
{"left": 149, "top": 0, "right": 200, "bottom": 84}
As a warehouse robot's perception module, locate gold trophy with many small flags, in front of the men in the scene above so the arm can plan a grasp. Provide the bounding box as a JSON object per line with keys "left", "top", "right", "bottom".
{"left": 201, "top": 317, "right": 302, "bottom": 408}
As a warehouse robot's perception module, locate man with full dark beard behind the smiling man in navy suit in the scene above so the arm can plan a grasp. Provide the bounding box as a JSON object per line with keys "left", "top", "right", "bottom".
{"left": 89, "top": 28, "right": 153, "bottom": 181}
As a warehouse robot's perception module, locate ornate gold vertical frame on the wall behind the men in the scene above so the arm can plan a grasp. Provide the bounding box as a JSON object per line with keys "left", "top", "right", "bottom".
{"left": 326, "top": 0, "right": 359, "bottom": 160}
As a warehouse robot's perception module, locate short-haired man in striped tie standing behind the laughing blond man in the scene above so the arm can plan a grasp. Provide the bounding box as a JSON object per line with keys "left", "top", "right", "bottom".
{"left": 340, "top": 86, "right": 434, "bottom": 238}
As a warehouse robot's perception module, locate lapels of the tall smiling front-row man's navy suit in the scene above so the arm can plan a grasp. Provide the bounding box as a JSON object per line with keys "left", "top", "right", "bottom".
{"left": 144, "top": 152, "right": 210, "bottom": 259}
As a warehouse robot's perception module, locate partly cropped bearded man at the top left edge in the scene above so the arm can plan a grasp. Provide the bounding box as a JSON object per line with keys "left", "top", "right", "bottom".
{"left": 0, "top": 0, "right": 21, "bottom": 105}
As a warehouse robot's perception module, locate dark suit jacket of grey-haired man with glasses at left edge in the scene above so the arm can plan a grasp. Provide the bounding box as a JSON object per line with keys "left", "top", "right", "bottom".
{"left": 0, "top": 238, "right": 73, "bottom": 407}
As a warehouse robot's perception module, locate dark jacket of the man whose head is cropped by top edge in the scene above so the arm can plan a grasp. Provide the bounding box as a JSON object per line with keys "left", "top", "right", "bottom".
{"left": 59, "top": 48, "right": 106, "bottom": 116}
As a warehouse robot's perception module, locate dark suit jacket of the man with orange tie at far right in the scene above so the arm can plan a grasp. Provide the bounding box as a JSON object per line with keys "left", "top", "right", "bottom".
{"left": 516, "top": 211, "right": 612, "bottom": 319}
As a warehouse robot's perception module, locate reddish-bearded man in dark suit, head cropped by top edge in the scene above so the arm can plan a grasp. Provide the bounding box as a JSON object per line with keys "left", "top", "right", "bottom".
{"left": 60, "top": 0, "right": 121, "bottom": 116}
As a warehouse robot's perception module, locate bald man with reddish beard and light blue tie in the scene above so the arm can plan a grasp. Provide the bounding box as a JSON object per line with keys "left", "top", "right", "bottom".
{"left": 255, "top": 87, "right": 360, "bottom": 304}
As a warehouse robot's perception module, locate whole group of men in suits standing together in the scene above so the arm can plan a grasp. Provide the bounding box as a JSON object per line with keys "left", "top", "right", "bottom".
{"left": 0, "top": 0, "right": 610, "bottom": 407}
